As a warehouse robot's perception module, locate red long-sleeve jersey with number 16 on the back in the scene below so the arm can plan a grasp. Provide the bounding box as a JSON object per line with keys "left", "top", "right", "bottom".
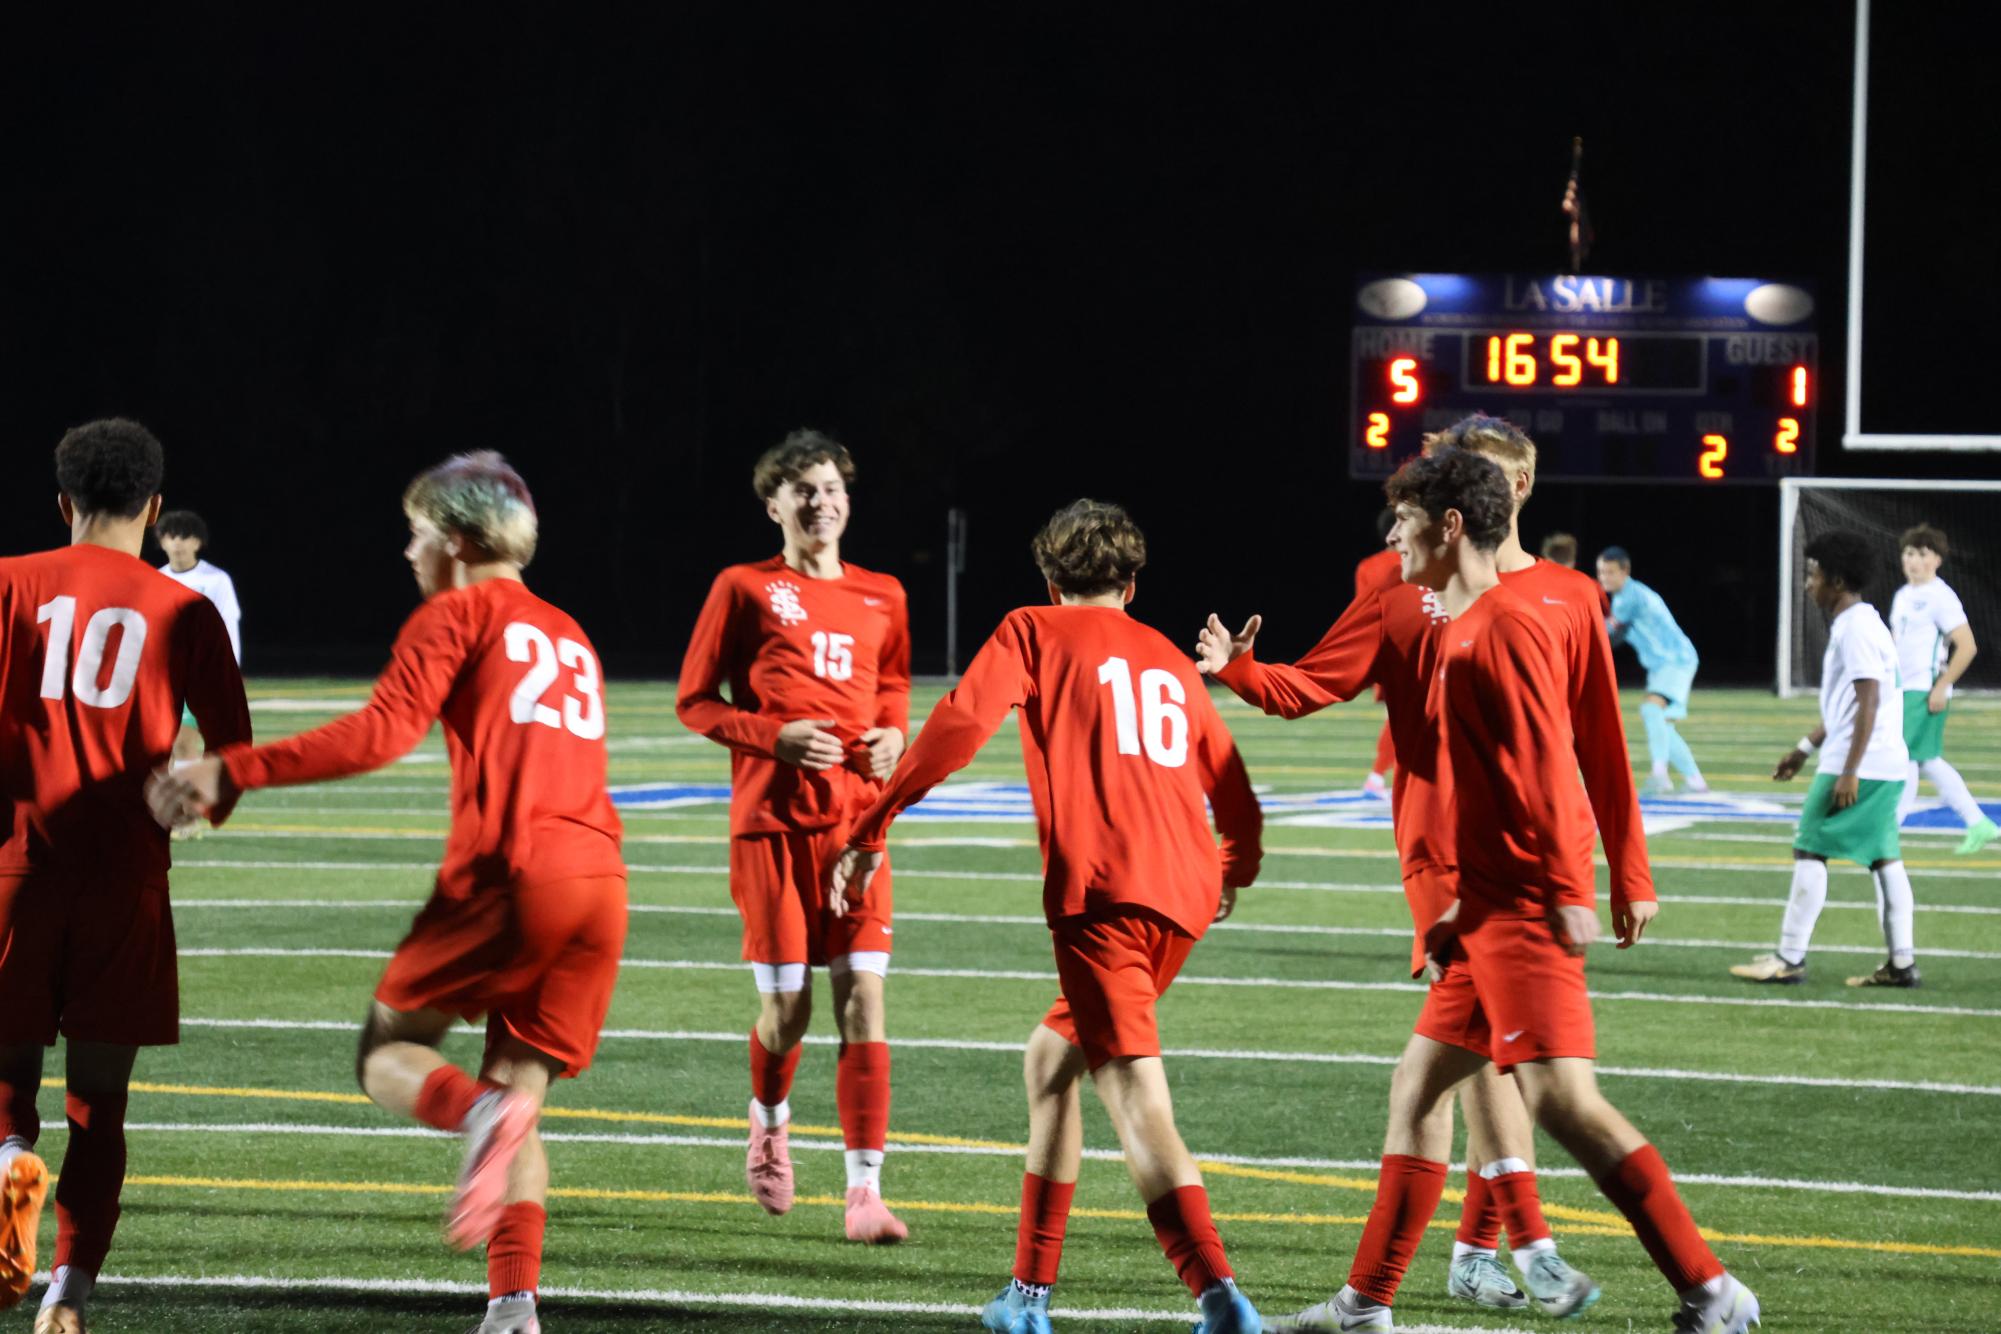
{"left": 848, "top": 606, "right": 1265, "bottom": 938}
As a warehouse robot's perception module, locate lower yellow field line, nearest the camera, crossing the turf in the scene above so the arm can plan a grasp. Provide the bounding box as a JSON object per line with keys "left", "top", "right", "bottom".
{"left": 113, "top": 1176, "right": 2001, "bottom": 1260}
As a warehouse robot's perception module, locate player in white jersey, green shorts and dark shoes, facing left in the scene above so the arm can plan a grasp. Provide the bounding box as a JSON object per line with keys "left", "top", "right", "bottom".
{"left": 1731, "top": 530, "right": 1919, "bottom": 986}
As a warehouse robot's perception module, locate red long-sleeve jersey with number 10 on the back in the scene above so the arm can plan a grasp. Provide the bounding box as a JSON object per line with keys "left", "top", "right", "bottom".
{"left": 0, "top": 544, "right": 250, "bottom": 888}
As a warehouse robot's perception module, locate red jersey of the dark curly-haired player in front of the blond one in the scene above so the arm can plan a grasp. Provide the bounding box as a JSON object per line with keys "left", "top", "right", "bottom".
{"left": 1433, "top": 586, "right": 1597, "bottom": 912}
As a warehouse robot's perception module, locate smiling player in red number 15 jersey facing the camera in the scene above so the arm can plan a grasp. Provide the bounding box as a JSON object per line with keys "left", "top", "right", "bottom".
{"left": 676, "top": 430, "right": 910, "bottom": 1244}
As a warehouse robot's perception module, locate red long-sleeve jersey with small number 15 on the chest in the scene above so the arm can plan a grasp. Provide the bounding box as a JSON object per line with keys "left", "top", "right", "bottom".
{"left": 674, "top": 556, "right": 910, "bottom": 834}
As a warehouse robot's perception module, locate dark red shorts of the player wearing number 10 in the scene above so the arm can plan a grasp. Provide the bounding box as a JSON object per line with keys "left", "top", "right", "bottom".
{"left": 0, "top": 872, "right": 180, "bottom": 1046}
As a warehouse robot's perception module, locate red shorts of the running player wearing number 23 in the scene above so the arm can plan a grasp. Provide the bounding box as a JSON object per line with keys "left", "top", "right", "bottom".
{"left": 376, "top": 876, "right": 626, "bottom": 1078}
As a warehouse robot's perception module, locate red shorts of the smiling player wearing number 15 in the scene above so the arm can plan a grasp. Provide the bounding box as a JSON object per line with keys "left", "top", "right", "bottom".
{"left": 730, "top": 824, "right": 892, "bottom": 966}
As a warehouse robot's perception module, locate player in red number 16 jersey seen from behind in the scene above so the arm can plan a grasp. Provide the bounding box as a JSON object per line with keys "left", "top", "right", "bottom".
{"left": 828, "top": 500, "right": 1263, "bottom": 1334}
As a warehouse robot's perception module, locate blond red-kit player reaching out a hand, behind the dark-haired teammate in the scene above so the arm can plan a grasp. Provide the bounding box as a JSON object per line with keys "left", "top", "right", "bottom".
{"left": 1199, "top": 416, "right": 1659, "bottom": 1316}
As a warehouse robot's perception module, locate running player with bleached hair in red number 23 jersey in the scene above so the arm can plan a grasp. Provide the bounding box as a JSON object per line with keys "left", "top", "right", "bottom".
{"left": 152, "top": 452, "right": 626, "bottom": 1334}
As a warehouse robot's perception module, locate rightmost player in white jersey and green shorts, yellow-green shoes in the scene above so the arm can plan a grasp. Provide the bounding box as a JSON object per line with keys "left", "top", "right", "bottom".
{"left": 1889, "top": 524, "right": 2001, "bottom": 852}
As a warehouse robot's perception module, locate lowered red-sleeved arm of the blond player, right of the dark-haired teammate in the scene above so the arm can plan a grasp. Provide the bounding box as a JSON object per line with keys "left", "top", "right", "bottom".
{"left": 1571, "top": 604, "right": 1661, "bottom": 948}
